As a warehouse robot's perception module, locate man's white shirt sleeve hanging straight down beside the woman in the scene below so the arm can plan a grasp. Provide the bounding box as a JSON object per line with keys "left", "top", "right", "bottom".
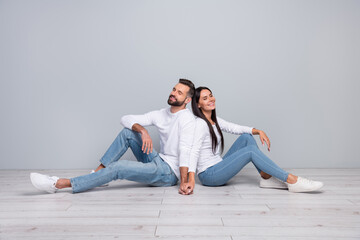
{"left": 179, "top": 115, "right": 195, "bottom": 167}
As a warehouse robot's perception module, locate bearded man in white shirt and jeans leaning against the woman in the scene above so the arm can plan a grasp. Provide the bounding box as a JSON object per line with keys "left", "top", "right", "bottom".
{"left": 30, "top": 79, "right": 195, "bottom": 194}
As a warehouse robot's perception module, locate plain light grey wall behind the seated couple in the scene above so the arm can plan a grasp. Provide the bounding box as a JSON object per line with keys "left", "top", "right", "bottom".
{"left": 0, "top": 0, "right": 360, "bottom": 169}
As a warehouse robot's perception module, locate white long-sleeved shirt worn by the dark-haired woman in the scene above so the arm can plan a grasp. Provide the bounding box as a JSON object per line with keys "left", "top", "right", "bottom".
{"left": 189, "top": 117, "right": 253, "bottom": 174}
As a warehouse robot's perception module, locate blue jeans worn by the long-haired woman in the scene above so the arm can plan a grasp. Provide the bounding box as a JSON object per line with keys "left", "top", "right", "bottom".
{"left": 198, "top": 133, "right": 289, "bottom": 186}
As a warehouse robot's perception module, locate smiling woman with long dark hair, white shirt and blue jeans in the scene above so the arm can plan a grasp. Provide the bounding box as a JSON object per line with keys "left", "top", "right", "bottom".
{"left": 189, "top": 87, "right": 323, "bottom": 192}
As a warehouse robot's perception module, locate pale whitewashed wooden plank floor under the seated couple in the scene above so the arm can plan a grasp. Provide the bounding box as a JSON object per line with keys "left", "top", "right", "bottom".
{"left": 0, "top": 168, "right": 360, "bottom": 240}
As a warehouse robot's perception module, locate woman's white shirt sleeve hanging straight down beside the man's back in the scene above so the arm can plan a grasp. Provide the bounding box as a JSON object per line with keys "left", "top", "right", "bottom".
{"left": 189, "top": 119, "right": 209, "bottom": 172}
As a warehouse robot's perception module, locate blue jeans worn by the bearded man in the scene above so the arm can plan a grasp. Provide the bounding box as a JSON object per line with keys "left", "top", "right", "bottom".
{"left": 70, "top": 128, "right": 178, "bottom": 193}
